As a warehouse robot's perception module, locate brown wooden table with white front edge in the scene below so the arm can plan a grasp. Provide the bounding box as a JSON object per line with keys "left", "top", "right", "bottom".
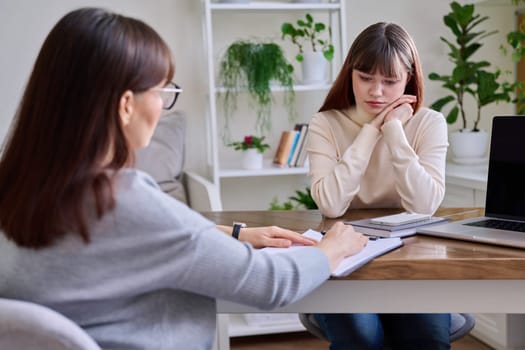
{"left": 204, "top": 208, "right": 525, "bottom": 348}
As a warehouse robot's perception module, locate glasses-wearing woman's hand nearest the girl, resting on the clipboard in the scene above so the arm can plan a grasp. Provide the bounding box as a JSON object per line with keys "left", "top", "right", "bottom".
{"left": 317, "top": 221, "right": 368, "bottom": 271}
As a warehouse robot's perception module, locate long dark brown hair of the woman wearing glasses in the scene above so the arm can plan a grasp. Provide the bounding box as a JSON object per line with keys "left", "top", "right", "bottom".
{"left": 0, "top": 8, "right": 174, "bottom": 248}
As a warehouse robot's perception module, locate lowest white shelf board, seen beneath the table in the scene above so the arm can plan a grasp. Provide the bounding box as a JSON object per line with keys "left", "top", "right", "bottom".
{"left": 228, "top": 314, "right": 306, "bottom": 337}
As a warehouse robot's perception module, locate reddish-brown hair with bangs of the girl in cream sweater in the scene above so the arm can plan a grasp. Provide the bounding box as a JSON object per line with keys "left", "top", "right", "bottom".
{"left": 319, "top": 22, "right": 423, "bottom": 112}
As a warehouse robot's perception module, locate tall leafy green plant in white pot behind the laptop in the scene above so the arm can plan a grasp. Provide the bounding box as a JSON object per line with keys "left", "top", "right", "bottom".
{"left": 429, "top": 1, "right": 510, "bottom": 162}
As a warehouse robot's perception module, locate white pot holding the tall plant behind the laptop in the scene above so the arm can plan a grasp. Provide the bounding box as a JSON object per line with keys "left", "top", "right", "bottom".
{"left": 448, "top": 130, "right": 489, "bottom": 163}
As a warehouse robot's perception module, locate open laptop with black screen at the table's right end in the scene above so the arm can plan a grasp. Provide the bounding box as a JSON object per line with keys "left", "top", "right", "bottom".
{"left": 417, "top": 116, "right": 525, "bottom": 248}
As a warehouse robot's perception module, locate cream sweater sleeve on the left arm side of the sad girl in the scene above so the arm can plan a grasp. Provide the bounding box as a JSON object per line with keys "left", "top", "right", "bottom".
{"left": 308, "top": 114, "right": 380, "bottom": 217}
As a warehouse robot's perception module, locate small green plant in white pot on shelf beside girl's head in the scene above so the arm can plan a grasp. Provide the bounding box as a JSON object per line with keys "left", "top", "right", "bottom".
{"left": 281, "top": 13, "right": 334, "bottom": 84}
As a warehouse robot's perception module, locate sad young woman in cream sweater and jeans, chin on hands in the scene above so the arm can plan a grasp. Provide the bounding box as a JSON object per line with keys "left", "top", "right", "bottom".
{"left": 308, "top": 23, "right": 450, "bottom": 350}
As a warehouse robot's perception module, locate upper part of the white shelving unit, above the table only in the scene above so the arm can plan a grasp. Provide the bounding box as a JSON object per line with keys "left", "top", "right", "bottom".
{"left": 203, "top": 0, "right": 347, "bottom": 209}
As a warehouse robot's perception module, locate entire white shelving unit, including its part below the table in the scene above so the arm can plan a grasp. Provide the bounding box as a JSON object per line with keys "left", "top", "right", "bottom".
{"left": 203, "top": 0, "right": 347, "bottom": 349}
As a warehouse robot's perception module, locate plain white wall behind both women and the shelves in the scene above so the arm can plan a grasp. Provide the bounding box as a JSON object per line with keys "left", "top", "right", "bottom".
{"left": 0, "top": 0, "right": 515, "bottom": 209}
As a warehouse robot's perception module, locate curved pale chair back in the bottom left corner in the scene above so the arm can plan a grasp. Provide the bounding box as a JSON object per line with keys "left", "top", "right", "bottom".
{"left": 0, "top": 298, "right": 101, "bottom": 350}
